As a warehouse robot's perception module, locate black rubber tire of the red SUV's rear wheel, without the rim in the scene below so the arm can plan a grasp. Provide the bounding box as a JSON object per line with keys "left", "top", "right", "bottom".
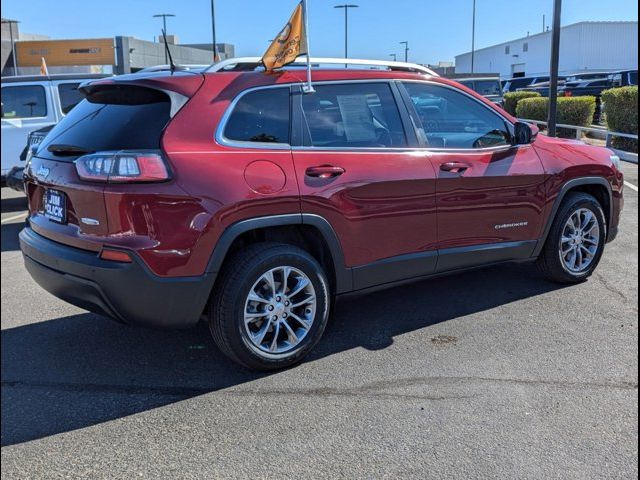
{"left": 209, "top": 243, "right": 331, "bottom": 370}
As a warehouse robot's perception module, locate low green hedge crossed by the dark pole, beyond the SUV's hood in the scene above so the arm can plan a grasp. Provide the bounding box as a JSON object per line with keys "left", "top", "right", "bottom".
{"left": 516, "top": 96, "right": 596, "bottom": 138}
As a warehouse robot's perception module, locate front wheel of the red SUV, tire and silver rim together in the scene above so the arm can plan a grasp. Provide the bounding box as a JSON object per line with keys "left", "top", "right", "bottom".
{"left": 538, "top": 192, "right": 606, "bottom": 283}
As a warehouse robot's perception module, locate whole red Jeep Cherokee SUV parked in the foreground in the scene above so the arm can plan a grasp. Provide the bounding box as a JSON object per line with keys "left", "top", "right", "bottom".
{"left": 20, "top": 61, "right": 623, "bottom": 370}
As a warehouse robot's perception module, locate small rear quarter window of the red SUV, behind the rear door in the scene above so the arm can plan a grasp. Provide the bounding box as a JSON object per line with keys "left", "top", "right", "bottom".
{"left": 224, "top": 88, "right": 290, "bottom": 144}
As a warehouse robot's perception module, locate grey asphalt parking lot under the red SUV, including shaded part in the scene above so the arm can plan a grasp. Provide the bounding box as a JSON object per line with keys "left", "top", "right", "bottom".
{"left": 1, "top": 164, "right": 638, "bottom": 479}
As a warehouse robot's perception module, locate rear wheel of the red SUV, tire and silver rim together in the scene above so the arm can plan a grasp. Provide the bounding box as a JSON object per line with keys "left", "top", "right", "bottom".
{"left": 209, "top": 243, "right": 330, "bottom": 370}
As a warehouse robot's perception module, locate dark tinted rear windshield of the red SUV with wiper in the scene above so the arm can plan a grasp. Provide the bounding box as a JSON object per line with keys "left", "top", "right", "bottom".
{"left": 37, "top": 86, "right": 171, "bottom": 161}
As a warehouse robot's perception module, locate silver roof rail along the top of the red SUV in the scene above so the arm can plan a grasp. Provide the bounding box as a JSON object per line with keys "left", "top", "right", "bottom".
{"left": 204, "top": 55, "right": 438, "bottom": 77}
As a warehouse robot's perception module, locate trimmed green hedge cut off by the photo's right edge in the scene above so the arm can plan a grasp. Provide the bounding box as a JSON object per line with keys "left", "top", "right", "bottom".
{"left": 602, "top": 86, "right": 638, "bottom": 153}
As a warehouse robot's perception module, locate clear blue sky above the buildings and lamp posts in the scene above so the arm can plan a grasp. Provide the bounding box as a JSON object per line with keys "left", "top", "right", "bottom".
{"left": 0, "top": 0, "right": 638, "bottom": 63}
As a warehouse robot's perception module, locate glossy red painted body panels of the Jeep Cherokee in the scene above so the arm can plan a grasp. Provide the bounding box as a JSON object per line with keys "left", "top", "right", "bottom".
{"left": 26, "top": 70, "right": 623, "bottom": 277}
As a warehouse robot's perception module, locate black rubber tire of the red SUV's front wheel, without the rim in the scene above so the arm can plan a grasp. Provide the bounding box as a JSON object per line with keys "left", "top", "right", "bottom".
{"left": 537, "top": 192, "right": 607, "bottom": 284}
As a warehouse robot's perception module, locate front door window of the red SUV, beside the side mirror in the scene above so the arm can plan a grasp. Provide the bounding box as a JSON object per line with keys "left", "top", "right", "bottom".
{"left": 404, "top": 82, "right": 511, "bottom": 149}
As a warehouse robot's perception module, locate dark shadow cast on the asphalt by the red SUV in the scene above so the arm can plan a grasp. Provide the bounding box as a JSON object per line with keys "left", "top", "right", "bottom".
{"left": 2, "top": 265, "right": 560, "bottom": 446}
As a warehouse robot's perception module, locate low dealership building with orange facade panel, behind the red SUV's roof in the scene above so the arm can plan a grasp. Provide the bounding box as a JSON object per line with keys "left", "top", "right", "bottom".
{"left": 1, "top": 19, "right": 235, "bottom": 76}
